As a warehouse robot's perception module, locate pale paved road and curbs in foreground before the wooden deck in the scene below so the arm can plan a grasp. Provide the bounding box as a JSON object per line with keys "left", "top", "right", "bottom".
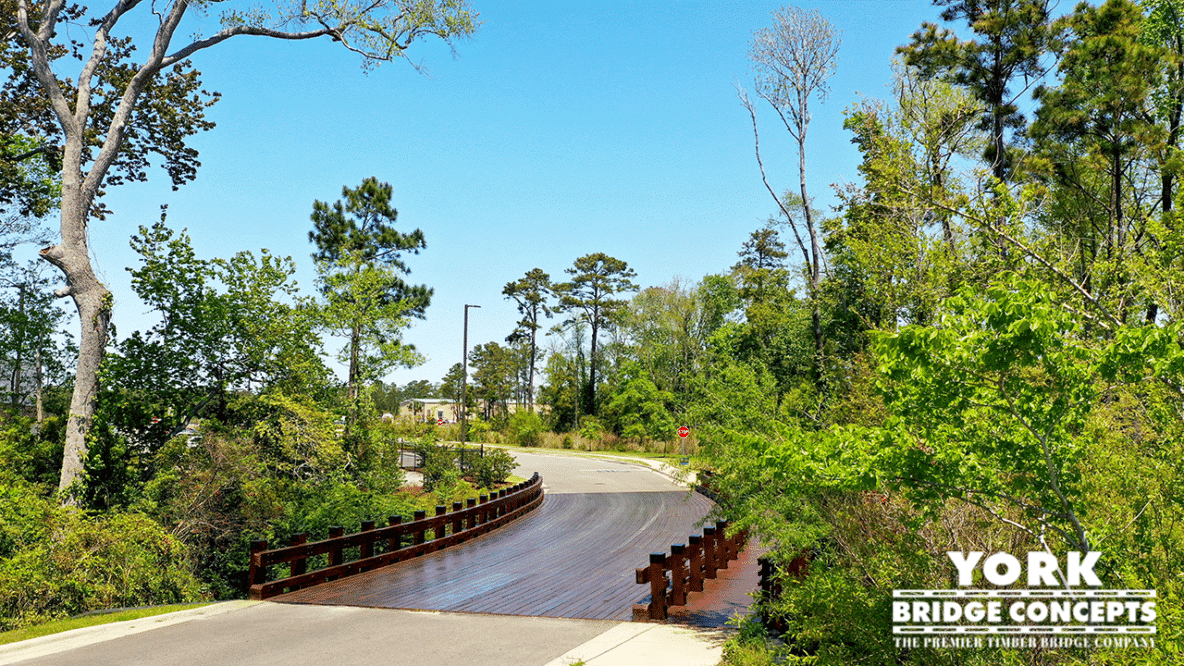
{"left": 0, "top": 601, "right": 725, "bottom": 666}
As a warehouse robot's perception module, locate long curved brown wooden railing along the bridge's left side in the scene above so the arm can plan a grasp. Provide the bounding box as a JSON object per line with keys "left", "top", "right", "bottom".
{"left": 249, "top": 473, "right": 542, "bottom": 600}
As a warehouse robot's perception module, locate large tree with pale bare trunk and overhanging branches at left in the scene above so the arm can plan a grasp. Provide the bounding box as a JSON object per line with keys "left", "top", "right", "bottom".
{"left": 13, "top": 0, "right": 476, "bottom": 501}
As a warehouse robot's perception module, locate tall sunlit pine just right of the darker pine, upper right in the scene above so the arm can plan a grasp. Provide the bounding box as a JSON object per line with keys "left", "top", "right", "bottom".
{"left": 1031, "top": 0, "right": 1166, "bottom": 319}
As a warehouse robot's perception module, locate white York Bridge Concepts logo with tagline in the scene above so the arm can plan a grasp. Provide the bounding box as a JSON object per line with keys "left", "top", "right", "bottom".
{"left": 892, "top": 551, "right": 1156, "bottom": 648}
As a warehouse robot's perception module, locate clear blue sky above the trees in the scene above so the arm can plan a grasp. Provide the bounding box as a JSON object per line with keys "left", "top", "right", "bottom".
{"left": 91, "top": 0, "right": 938, "bottom": 384}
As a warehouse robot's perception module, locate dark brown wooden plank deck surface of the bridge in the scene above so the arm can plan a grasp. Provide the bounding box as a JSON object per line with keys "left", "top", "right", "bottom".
{"left": 271, "top": 491, "right": 712, "bottom": 620}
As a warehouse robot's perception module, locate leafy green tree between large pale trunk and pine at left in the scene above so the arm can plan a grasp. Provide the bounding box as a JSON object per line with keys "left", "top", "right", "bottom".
{"left": 86, "top": 220, "right": 330, "bottom": 506}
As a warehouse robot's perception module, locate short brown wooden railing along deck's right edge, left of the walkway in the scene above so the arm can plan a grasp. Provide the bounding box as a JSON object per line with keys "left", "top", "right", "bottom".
{"left": 633, "top": 520, "right": 748, "bottom": 622}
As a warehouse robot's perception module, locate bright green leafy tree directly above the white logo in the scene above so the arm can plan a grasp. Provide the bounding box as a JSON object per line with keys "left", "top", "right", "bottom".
{"left": 868, "top": 275, "right": 1184, "bottom": 551}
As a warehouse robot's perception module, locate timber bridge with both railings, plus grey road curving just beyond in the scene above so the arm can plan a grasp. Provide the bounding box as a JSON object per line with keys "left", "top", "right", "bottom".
{"left": 251, "top": 453, "right": 758, "bottom": 626}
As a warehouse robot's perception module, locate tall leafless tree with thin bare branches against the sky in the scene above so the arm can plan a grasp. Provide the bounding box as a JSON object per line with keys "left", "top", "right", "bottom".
{"left": 739, "top": 6, "right": 841, "bottom": 359}
